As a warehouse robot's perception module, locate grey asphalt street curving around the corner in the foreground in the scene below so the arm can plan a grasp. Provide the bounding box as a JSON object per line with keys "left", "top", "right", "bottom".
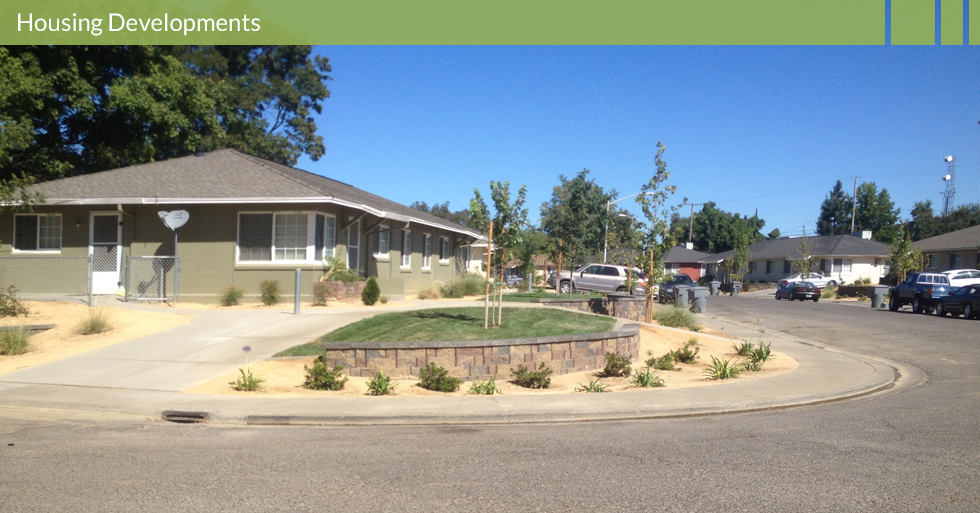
{"left": 0, "top": 296, "right": 980, "bottom": 512}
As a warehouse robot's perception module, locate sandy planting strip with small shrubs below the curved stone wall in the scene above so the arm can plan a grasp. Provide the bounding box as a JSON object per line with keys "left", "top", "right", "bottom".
{"left": 185, "top": 326, "right": 799, "bottom": 397}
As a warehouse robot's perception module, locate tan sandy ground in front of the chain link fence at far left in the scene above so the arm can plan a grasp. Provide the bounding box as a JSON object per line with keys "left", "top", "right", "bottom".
{"left": 0, "top": 301, "right": 191, "bottom": 374}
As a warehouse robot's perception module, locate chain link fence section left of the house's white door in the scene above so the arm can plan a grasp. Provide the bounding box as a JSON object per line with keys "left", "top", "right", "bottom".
{"left": 0, "top": 256, "right": 92, "bottom": 305}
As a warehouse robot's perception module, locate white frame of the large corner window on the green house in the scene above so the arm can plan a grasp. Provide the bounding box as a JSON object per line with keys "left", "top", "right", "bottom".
{"left": 235, "top": 210, "right": 337, "bottom": 266}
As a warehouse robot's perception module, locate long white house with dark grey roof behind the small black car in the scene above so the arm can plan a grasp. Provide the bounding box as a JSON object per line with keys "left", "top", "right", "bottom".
{"left": 705, "top": 232, "right": 889, "bottom": 284}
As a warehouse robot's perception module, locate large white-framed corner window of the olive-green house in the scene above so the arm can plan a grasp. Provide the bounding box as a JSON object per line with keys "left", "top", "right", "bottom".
{"left": 238, "top": 212, "right": 336, "bottom": 263}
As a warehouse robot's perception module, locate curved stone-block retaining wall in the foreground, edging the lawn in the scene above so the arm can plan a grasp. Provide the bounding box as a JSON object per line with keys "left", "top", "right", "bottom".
{"left": 323, "top": 324, "right": 640, "bottom": 379}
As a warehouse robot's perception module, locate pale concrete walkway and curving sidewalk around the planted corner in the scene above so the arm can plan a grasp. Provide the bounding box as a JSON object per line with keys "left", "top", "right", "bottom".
{"left": 0, "top": 301, "right": 924, "bottom": 424}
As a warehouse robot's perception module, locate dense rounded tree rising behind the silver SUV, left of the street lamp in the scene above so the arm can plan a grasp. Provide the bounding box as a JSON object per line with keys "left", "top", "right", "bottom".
{"left": 541, "top": 169, "right": 618, "bottom": 267}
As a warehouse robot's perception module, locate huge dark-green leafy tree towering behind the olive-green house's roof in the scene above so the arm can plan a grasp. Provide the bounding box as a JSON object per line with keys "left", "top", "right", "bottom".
{"left": 0, "top": 46, "right": 331, "bottom": 186}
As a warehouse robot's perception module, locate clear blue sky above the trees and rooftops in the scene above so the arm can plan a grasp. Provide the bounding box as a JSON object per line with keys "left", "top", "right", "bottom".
{"left": 297, "top": 46, "right": 980, "bottom": 235}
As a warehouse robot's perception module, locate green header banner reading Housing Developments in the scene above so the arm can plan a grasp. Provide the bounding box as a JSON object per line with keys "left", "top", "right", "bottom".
{"left": 0, "top": 0, "right": 960, "bottom": 45}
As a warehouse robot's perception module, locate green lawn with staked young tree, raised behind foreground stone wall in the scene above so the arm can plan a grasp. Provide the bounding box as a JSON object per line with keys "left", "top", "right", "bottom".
{"left": 276, "top": 308, "right": 616, "bottom": 356}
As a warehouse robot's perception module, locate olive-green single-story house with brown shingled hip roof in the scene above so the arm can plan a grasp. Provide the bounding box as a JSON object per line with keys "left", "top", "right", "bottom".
{"left": 0, "top": 149, "right": 480, "bottom": 302}
